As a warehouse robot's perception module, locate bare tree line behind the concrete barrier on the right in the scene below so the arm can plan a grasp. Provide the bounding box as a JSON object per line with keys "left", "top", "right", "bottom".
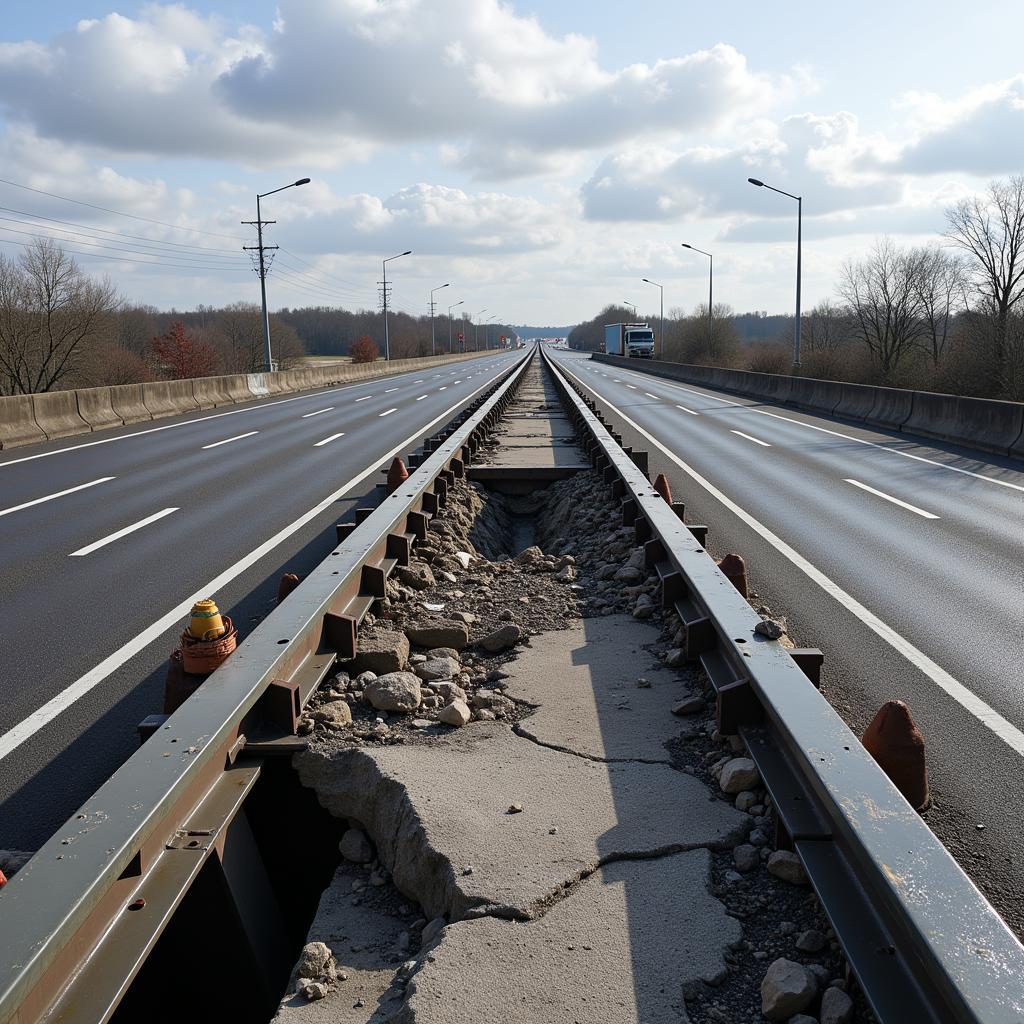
{"left": 569, "top": 176, "right": 1024, "bottom": 401}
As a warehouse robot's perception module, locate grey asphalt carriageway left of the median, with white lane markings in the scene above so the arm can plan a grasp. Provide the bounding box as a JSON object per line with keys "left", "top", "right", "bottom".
{"left": 0, "top": 352, "right": 525, "bottom": 850}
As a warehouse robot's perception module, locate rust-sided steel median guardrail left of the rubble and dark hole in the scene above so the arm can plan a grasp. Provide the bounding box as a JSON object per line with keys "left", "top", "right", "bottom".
{"left": 0, "top": 353, "right": 531, "bottom": 1024}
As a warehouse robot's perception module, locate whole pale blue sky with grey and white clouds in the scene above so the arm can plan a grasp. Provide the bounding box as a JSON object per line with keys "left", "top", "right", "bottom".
{"left": 0, "top": 0, "right": 1024, "bottom": 325}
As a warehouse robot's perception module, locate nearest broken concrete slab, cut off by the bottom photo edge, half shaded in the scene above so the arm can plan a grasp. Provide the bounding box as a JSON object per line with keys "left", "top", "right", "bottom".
{"left": 395, "top": 850, "right": 741, "bottom": 1024}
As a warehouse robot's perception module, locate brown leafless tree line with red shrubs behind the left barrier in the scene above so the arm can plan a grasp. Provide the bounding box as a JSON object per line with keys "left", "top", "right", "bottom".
{"left": 0, "top": 238, "right": 514, "bottom": 394}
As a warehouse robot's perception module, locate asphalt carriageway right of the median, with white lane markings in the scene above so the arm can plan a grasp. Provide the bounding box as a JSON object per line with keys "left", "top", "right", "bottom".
{"left": 555, "top": 352, "right": 1024, "bottom": 936}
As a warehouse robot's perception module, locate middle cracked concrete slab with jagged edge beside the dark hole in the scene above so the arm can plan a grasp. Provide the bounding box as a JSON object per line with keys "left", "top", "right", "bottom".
{"left": 295, "top": 722, "right": 750, "bottom": 921}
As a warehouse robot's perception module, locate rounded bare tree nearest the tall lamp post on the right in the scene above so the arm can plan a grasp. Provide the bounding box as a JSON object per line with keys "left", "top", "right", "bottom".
{"left": 840, "top": 239, "right": 924, "bottom": 378}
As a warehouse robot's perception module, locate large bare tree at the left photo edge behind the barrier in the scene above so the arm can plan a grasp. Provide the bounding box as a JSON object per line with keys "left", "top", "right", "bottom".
{"left": 0, "top": 239, "right": 118, "bottom": 394}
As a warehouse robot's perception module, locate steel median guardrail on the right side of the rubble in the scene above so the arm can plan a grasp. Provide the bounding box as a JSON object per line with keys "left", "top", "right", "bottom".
{"left": 545, "top": 346, "right": 1024, "bottom": 1024}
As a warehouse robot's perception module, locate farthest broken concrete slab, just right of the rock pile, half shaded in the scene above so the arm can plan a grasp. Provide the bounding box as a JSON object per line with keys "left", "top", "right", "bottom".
{"left": 505, "top": 615, "right": 688, "bottom": 763}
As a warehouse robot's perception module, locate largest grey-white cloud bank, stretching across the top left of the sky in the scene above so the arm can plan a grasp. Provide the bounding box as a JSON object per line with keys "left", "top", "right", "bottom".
{"left": 0, "top": 0, "right": 809, "bottom": 169}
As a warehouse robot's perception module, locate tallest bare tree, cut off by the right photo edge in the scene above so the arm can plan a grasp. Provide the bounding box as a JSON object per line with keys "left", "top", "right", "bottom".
{"left": 946, "top": 176, "right": 1024, "bottom": 381}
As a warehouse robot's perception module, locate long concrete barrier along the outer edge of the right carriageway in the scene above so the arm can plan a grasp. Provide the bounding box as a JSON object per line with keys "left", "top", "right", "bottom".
{"left": 591, "top": 352, "right": 1024, "bottom": 459}
